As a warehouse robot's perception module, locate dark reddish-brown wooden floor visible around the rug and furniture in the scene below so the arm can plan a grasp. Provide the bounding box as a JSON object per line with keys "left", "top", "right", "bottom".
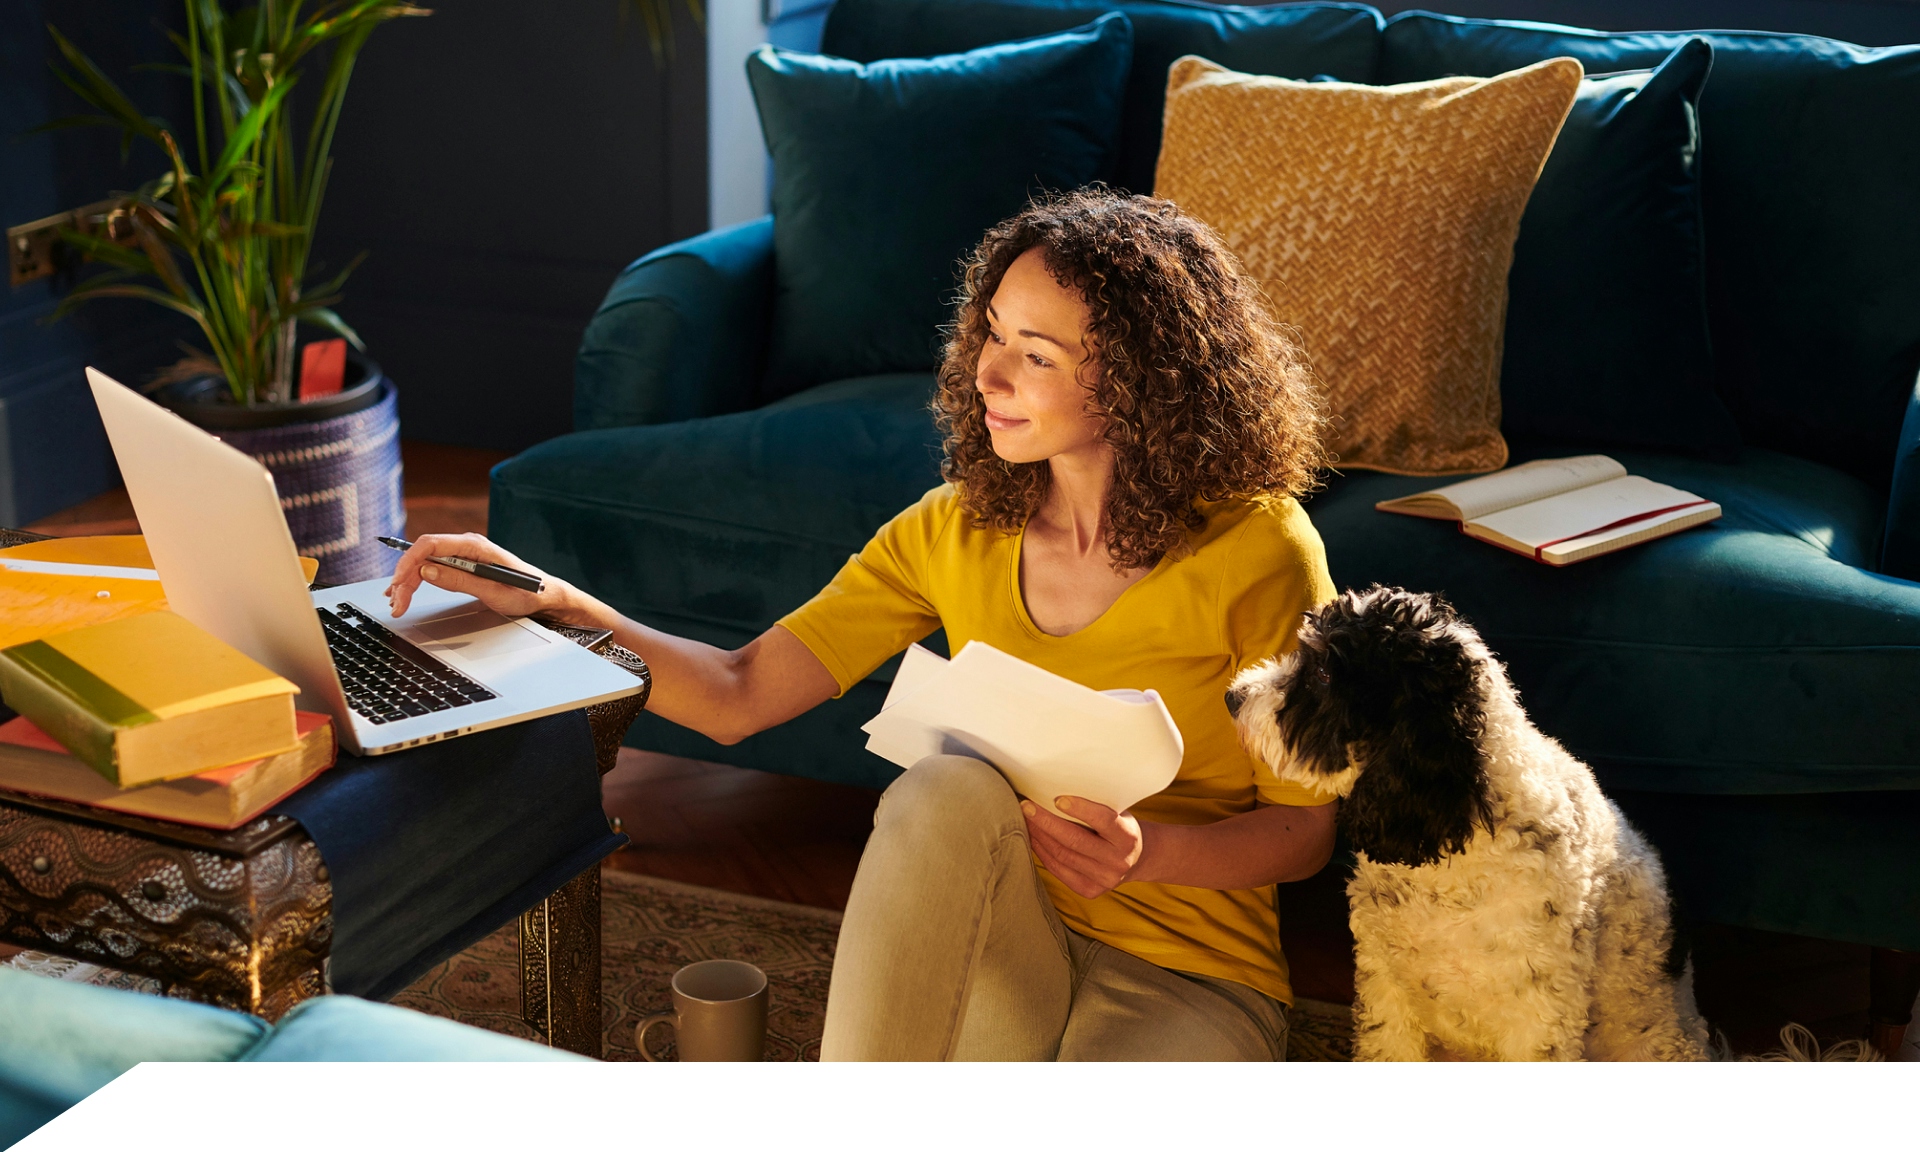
{"left": 22, "top": 442, "right": 1920, "bottom": 1060}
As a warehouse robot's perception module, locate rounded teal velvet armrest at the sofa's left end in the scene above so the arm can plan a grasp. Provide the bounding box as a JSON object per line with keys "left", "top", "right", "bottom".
{"left": 574, "top": 217, "right": 774, "bottom": 430}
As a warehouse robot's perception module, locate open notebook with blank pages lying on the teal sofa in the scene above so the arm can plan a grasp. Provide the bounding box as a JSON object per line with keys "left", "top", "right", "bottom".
{"left": 1373, "top": 455, "right": 1720, "bottom": 566}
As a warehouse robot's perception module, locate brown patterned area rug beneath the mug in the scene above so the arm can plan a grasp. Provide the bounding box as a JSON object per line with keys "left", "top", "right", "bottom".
{"left": 394, "top": 870, "right": 1352, "bottom": 1060}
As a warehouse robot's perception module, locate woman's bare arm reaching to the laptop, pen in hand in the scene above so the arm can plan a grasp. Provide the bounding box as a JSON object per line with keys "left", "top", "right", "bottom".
{"left": 388, "top": 534, "right": 839, "bottom": 743}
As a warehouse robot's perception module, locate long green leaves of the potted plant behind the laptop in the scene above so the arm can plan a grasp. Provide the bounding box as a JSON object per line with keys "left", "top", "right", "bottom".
{"left": 50, "top": 0, "right": 428, "bottom": 401}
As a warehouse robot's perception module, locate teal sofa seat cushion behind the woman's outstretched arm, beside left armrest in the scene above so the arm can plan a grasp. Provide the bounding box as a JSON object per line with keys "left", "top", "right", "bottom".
{"left": 488, "top": 372, "right": 939, "bottom": 647}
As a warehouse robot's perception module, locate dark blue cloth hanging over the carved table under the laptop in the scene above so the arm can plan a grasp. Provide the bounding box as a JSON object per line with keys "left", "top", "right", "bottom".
{"left": 273, "top": 710, "right": 626, "bottom": 1000}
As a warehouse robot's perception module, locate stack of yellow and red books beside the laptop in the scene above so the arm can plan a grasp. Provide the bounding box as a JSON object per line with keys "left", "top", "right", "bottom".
{"left": 0, "top": 611, "right": 336, "bottom": 828}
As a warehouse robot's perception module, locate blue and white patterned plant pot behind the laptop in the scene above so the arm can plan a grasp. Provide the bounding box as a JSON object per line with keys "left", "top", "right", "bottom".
{"left": 154, "top": 353, "right": 407, "bottom": 584}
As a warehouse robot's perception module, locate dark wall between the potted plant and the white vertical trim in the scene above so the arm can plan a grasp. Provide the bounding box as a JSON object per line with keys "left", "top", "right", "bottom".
{"left": 319, "top": 0, "right": 707, "bottom": 451}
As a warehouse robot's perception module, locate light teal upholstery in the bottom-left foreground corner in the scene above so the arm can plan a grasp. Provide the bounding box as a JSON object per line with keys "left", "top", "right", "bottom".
{"left": 0, "top": 966, "right": 586, "bottom": 1148}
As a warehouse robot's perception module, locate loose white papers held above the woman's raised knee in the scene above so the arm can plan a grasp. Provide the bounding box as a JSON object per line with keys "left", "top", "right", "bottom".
{"left": 862, "top": 641, "right": 1187, "bottom": 820}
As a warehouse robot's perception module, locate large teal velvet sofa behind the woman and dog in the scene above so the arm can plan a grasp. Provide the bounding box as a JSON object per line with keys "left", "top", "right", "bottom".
{"left": 492, "top": 0, "right": 1920, "bottom": 948}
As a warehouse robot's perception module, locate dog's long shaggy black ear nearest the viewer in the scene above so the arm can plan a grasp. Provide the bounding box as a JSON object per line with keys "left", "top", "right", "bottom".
{"left": 1329, "top": 589, "right": 1492, "bottom": 864}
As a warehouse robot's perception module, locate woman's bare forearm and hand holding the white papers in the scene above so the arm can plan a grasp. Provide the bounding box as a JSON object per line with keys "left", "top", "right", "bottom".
{"left": 1020, "top": 797, "right": 1340, "bottom": 900}
